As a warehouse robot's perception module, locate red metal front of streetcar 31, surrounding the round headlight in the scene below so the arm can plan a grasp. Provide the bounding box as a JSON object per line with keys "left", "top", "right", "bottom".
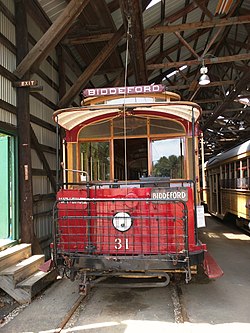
{"left": 57, "top": 188, "right": 199, "bottom": 255}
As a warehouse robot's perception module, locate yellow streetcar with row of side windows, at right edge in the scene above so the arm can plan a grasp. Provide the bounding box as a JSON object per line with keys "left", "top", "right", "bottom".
{"left": 203, "top": 140, "right": 250, "bottom": 233}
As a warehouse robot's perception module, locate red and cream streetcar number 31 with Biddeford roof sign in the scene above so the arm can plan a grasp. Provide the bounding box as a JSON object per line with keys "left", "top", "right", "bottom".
{"left": 52, "top": 85, "right": 222, "bottom": 290}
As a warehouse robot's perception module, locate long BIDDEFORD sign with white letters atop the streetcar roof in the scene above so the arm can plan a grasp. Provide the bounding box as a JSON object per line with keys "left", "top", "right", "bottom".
{"left": 83, "top": 84, "right": 165, "bottom": 97}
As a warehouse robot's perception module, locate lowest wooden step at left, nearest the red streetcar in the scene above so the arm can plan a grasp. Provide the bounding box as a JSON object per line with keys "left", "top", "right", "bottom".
{"left": 16, "top": 269, "right": 57, "bottom": 300}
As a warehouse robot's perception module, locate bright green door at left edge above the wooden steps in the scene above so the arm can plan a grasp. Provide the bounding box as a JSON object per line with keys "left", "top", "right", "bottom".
{"left": 0, "top": 133, "right": 16, "bottom": 240}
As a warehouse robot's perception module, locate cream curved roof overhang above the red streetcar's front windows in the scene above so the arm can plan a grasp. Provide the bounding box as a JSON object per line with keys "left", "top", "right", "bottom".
{"left": 53, "top": 101, "right": 201, "bottom": 131}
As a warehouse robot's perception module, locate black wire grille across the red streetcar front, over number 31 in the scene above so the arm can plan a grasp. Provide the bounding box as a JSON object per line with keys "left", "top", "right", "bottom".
{"left": 54, "top": 198, "right": 187, "bottom": 256}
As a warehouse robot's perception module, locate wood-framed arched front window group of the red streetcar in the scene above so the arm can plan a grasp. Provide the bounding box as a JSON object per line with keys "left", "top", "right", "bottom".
{"left": 74, "top": 116, "right": 188, "bottom": 181}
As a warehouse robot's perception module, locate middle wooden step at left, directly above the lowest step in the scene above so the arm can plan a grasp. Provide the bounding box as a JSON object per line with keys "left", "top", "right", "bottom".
{"left": 0, "top": 254, "right": 45, "bottom": 286}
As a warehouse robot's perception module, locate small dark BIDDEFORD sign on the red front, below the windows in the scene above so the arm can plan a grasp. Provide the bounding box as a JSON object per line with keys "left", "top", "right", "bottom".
{"left": 151, "top": 187, "right": 188, "bottom": 201}
